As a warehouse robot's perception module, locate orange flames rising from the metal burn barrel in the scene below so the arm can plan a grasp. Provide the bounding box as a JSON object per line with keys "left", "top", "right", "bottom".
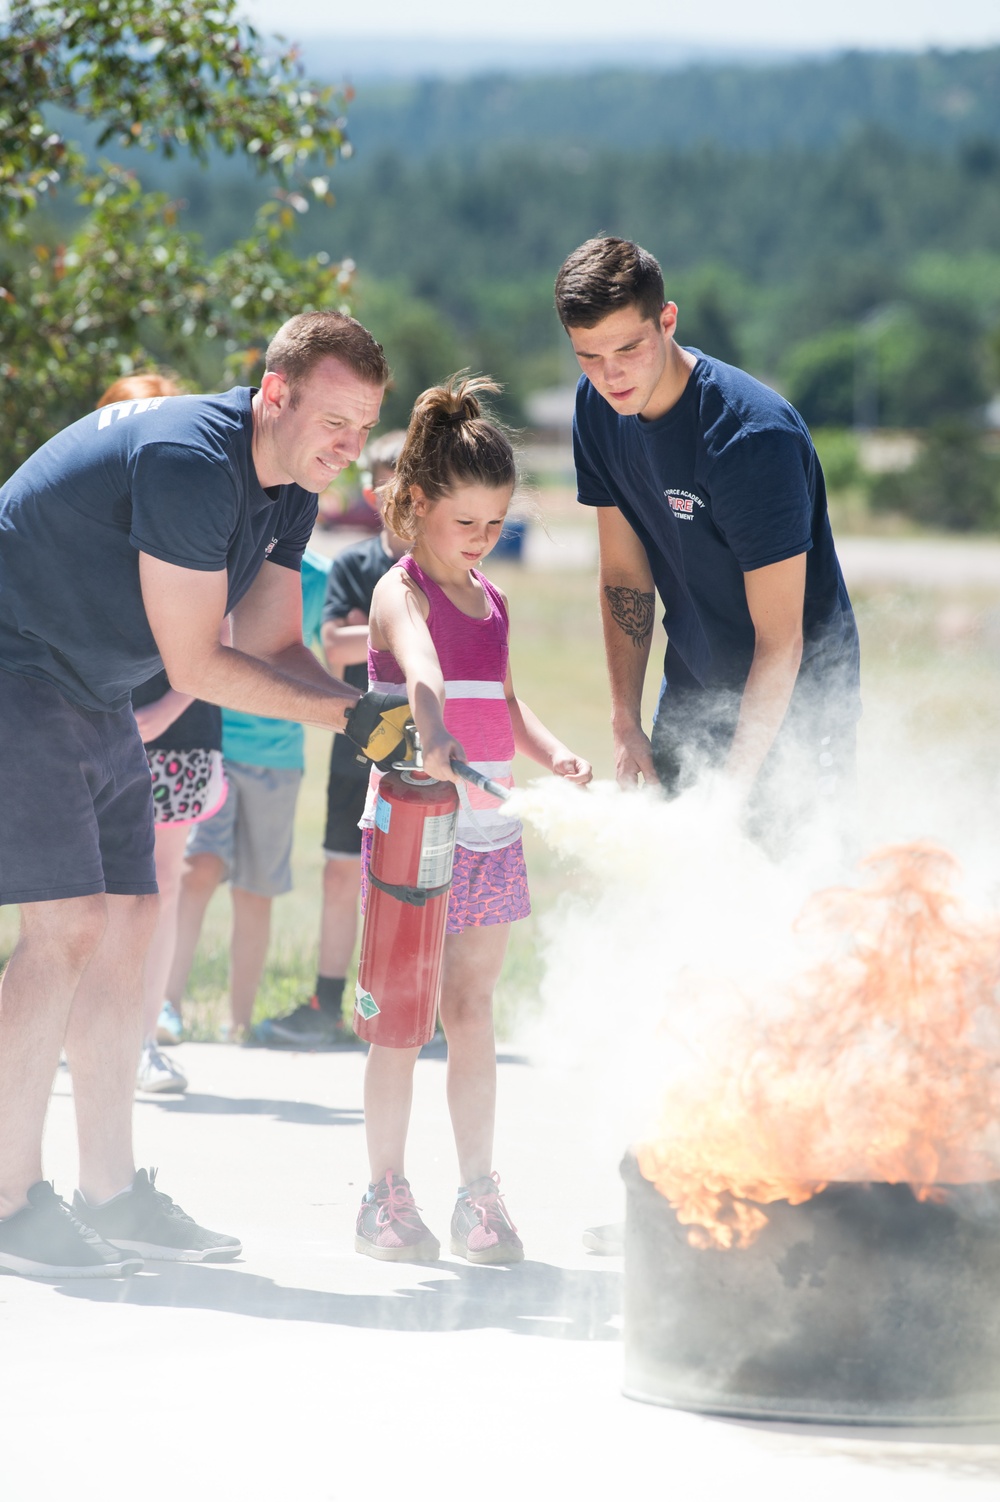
{"left": 635, "top": 844, "right": 1000, "bottom": 1248}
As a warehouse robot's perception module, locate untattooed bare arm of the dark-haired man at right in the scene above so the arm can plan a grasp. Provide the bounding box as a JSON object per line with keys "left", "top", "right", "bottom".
{"left": 725, "top": 553, "right": 806, "bottom": 796}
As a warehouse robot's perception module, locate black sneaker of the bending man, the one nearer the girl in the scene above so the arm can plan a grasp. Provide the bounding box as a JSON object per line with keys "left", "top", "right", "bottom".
{"left": 74, "top": 1169, "right": 243, "bottom": 1262}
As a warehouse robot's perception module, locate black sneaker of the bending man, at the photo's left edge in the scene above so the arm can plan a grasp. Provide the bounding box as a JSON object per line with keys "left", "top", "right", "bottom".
{"left": 0, "top": 1179, "right": 143, "bottom": 1278}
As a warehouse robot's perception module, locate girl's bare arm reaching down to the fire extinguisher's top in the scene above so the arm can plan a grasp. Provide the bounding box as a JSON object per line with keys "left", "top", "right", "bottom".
{"left": 368, "top": 568, "right": 465, "bottom": 783}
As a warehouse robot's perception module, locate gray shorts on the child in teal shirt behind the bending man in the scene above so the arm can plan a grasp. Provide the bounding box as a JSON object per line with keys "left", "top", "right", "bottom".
{"left": 186, "top": 762, "right": 302, "bottom": 897}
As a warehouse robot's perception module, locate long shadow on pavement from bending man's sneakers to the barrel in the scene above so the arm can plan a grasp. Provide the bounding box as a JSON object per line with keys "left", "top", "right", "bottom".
{"left": 57, "top": 1262, "right": 620, "bottom": 1340}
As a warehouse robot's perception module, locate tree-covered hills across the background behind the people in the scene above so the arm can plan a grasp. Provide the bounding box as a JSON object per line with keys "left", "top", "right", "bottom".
{"left": 42, "top": 48, "right": 1000, "bottom": 427}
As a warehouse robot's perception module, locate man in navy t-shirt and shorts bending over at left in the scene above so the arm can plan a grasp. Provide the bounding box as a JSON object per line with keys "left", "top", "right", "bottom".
{"left": 0, "top": 312, "right": 402, "bottom": 1277}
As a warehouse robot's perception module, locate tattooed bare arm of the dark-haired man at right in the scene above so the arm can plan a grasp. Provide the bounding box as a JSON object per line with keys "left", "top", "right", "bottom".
{"left": 598, "top": 506, "right": 656, "bottom": 786}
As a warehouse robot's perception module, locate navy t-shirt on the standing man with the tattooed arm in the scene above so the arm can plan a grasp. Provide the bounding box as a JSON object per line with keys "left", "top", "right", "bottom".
{"left": 574, "top": 350, "right": 859, "bottom": 718}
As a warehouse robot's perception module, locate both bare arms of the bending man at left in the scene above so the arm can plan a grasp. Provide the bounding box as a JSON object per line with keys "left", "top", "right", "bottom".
{"left": 140, "top": 553, "right": 359, "bottom": 730}
